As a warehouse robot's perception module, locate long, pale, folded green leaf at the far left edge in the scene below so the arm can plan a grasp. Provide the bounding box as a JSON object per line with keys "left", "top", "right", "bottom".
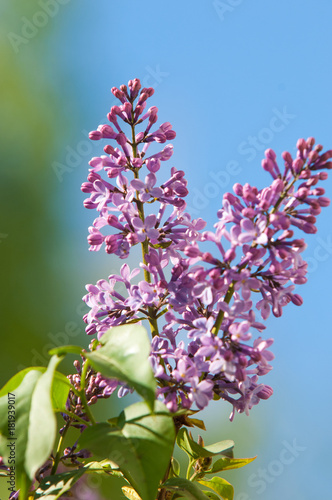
{"left": 0, "top": 356, "right": 61, "bottom": 490}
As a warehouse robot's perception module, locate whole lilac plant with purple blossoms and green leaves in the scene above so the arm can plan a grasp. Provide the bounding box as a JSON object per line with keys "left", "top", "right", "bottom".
{"left": 0, "top": 79, "right": 332, "bottom": 500}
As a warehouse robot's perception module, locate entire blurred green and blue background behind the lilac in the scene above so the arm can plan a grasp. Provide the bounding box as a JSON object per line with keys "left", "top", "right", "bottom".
{"left": 0, "top": 0, "right": 332, "bottom": 500}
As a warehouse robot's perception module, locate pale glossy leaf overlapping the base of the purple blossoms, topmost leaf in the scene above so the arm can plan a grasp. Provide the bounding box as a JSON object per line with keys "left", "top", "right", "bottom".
{"left": 83, "top": 325, "right": 156, "bottom": 409}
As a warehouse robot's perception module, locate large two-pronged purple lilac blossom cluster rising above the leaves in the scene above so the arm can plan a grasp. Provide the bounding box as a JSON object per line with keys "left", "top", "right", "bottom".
{"left": 82, "top": 79, "right": 332, "bottom": 416}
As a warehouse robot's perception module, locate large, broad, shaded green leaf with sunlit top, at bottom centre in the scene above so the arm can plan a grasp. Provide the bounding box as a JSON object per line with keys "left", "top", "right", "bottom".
{"left": 78, "top": 401, "right": 175, "bottom": 500}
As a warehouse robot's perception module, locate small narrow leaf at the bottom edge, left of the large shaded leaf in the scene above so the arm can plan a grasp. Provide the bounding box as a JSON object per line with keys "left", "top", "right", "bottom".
{"left": 35, "top": 468, "right": 85, "bottom": 500}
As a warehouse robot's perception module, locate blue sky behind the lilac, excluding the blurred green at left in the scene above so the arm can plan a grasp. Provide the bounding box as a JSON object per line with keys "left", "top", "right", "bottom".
{"left": 3, "top": 0, "right": 332, "bottom": 500}
